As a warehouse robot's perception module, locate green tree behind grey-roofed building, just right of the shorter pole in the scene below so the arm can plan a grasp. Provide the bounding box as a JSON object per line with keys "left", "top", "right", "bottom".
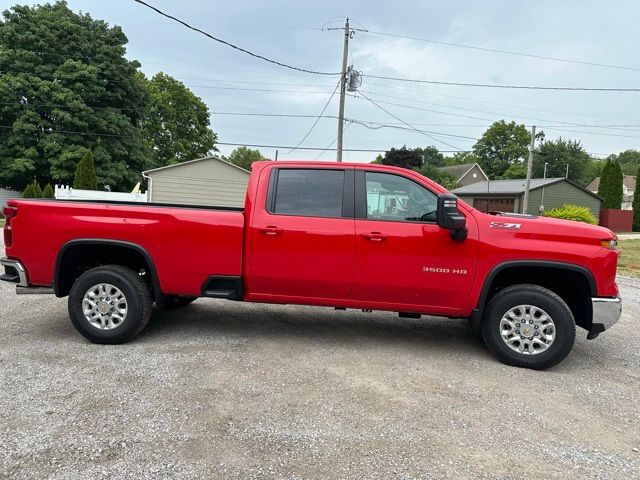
{"left": 532, "top": 138, "right": 595, "bottom": 186}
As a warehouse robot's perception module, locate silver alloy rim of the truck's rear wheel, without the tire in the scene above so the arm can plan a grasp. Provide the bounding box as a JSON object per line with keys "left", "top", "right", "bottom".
{"left": 82, "top": 283, "right": 127, "bottom": 330}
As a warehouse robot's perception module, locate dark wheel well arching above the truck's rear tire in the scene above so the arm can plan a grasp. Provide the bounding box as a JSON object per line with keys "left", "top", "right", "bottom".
{"left": 54, "top": 240, "right": 160, "bottom": 299}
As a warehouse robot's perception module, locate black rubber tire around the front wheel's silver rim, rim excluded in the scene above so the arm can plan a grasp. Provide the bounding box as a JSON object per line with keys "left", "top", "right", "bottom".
{"left": 481, "top": 284, "right": 576, "bottom": 370}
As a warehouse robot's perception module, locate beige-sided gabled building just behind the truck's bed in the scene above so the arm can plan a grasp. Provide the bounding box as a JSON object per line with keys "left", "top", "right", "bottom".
{"left": 142, "top": 157, "right": 250, "bottom": 207}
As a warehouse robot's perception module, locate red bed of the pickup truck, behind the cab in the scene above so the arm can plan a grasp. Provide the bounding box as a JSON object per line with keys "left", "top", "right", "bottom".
{"left": 7, "top": 199, "right": 244, "bottom": 296}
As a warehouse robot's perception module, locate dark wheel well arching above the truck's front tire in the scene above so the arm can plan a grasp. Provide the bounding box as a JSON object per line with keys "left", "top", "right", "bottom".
{"left": 478, "top": 266, "right": 595, "bottom": 330}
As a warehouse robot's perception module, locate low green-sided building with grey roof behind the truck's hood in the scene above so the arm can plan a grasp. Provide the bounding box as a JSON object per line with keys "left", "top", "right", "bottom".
{"left": 453, "top": 177, "right": 602, "bottom": 218}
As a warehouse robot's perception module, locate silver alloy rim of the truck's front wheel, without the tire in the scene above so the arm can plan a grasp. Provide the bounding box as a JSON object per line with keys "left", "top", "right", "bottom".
{"left": 500, "top": 305, "right": 556, "bottom": 355}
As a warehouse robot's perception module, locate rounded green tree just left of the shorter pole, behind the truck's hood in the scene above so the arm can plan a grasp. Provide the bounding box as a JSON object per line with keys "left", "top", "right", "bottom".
{"left": 473, "top": 120, "right": 544, "bottom": 178}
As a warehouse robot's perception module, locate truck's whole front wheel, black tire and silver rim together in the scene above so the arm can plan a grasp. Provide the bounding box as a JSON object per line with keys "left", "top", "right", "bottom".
{"left": 482, "top": 285, "right": 576, "bottom": 370}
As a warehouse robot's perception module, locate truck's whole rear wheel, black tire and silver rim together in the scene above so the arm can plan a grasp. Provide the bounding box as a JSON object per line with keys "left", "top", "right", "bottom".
{"left": 68, "top": 265, "right": 152, "bottom": 344}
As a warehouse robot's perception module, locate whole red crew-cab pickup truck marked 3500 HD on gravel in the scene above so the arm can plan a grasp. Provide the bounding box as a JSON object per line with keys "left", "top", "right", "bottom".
{"left": 0, "top": 162, "right": 621, "bottom": 369}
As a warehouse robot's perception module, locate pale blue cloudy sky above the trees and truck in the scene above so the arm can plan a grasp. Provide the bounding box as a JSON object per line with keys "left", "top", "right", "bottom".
{"left": 8, "top": 0, "right": 640, "bottom": 161}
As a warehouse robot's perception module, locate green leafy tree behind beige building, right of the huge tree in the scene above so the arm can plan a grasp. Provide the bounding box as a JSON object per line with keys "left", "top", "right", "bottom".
{"left": 142, "top": 72, "right": 217, "bottom": 167}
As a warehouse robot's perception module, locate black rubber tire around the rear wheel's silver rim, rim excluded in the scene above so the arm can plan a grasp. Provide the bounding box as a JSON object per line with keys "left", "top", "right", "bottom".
{"left": 68, "top": 265, "right": 153, "bottom": 344}
